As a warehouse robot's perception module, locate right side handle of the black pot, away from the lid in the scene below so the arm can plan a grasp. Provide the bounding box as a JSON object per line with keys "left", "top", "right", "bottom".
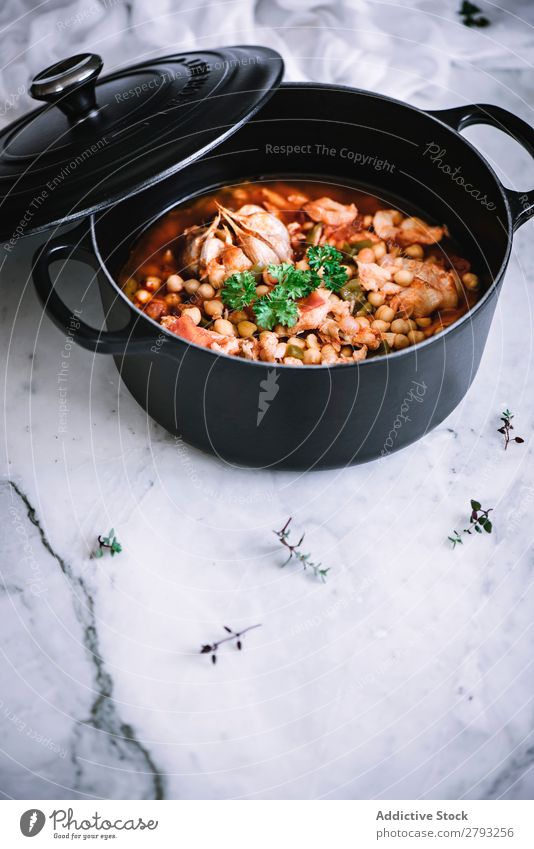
{"left": 428, "top": 103, "right": 534, "bottom": 230}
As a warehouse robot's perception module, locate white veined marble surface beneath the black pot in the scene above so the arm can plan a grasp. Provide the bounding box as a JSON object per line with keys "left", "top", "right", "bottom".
{"left": 0, "top": 0, "right": 534, "bottom": 799}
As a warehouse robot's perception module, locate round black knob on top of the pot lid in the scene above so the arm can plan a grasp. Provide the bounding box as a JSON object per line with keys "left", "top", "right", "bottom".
{"left": 30, "top": 53, "right": 103, "bottom": 124}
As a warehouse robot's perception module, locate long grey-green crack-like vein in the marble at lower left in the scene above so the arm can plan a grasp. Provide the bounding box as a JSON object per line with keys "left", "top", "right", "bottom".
{"left": 7, "top": 480, "right": 165, "bottom": 799}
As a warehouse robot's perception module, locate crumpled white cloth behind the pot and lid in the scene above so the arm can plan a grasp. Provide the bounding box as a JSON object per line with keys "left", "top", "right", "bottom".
{"left": 0, "top": 0, "right": 534, "bottom": 126}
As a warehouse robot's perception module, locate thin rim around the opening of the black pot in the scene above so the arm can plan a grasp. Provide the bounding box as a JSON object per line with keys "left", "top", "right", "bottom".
{"left": 89, "top": 82, "right": 514, "bottom": 371}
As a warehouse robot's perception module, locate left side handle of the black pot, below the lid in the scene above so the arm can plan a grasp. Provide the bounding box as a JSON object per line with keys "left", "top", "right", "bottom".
{"left": 33, "top": 225, "right": 162, "bottom": 356}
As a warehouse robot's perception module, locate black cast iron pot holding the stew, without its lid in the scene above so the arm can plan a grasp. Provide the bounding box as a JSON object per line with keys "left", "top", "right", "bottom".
{"left": 34, "top": 84, "right": 534, "bottom": 469}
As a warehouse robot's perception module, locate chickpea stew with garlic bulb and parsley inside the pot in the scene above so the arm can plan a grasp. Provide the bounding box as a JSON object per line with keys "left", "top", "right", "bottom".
{"left": 119, "top": 180, "right": 480, "bottom": 366}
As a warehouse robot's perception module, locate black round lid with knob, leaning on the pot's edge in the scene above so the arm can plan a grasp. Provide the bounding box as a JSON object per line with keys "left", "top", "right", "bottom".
{"left": 0, "top": 45, "right": 283, "bottom": 240}
